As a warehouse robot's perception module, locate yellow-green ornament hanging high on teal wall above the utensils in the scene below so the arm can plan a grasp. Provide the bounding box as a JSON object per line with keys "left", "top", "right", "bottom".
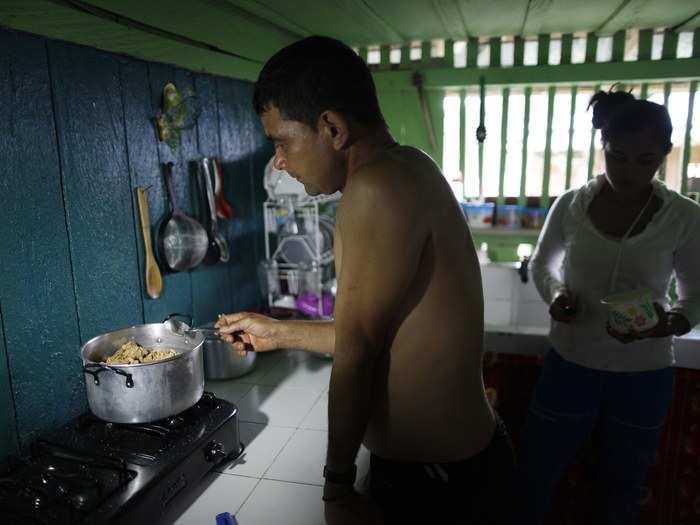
{"left": 155, "top": 83, "right": 202, "bottom": 152}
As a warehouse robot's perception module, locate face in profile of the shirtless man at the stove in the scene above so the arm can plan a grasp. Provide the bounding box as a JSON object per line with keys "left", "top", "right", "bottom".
{"left": 260, "top": 106, "right": 342, "bottom": 195}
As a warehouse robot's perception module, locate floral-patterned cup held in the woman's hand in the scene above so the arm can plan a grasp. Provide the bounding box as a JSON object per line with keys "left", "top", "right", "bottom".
{"left": 600, "top": 289, "right": 659, "bottom": 334}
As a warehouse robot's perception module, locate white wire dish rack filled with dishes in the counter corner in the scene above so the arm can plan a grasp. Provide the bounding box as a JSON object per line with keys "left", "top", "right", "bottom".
{"left": 260, "top": 194, "right": 340, "bottom": 318}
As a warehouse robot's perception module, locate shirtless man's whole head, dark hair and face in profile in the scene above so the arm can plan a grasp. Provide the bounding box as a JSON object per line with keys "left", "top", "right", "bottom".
{"left": 253, "top": 36, "right": 386, "bottom": 195}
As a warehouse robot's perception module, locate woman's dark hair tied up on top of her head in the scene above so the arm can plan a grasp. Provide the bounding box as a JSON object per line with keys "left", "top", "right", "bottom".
{"left": 588, "top": 89, "right": 673, "bottom": 147}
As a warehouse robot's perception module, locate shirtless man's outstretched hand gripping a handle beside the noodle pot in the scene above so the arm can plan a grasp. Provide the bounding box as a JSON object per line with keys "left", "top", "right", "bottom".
{"left": 215, "top": 312, "right": 282, "bottom": 356}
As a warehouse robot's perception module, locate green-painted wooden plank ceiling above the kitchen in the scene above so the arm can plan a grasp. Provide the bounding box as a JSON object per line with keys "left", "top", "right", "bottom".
{"left": 0, "top": 0, "right": 700, "bottom": 78}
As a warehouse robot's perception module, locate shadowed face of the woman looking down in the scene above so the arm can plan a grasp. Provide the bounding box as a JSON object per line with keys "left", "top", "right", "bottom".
{"left": 604, "top": 128, "right": 666, "bottom": 194}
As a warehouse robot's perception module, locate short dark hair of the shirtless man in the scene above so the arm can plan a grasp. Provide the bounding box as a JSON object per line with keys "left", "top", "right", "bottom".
{"left": 253, "top": 36, "right": 385, "bottom": 130}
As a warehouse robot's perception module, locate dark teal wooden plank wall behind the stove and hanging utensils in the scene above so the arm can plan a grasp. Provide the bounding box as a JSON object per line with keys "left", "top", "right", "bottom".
{"left": 0, "top": 28, "right": 272, "bottom": 460}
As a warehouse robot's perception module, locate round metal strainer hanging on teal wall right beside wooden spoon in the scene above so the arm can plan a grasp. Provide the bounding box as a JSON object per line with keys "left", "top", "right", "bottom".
{"left": 157, "top": 162, "right": 208, "bottom": 272}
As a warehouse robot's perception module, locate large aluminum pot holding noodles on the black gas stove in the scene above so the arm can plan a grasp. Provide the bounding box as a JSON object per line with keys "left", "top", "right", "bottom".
{"left": 80, "top": 323, "right": 204, "bottom": 423}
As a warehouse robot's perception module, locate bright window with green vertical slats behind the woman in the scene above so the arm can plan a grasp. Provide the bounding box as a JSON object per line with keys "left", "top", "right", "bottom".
{"left": 443, "top": 82, "right": 700, "bottom": 202}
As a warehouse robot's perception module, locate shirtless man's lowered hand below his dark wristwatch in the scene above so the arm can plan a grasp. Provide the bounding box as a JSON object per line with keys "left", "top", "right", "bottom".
{"left": 323, "top": 482, "right": 383, "bottom": 525}
